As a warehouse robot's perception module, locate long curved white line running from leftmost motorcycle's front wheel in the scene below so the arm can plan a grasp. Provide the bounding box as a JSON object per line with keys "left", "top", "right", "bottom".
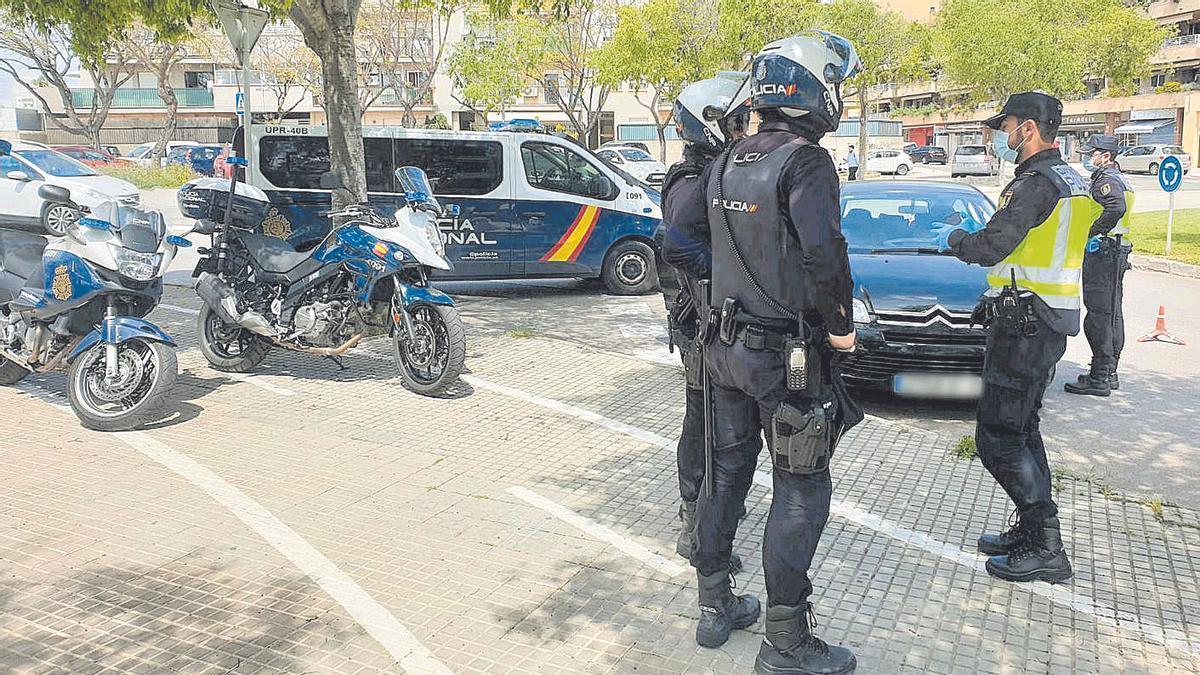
{"left": 20, "top": 384, "right": 452, "bottom": 675}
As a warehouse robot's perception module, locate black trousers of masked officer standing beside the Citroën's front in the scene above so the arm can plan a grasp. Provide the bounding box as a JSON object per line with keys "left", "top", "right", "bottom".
{"left": 976, "top": 321, "right": 1067, "bottom": 524}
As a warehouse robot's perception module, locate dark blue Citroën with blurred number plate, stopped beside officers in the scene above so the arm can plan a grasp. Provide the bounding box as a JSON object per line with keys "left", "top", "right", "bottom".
{"left": 841, "top": 180, "right": 995, "bottom": 399}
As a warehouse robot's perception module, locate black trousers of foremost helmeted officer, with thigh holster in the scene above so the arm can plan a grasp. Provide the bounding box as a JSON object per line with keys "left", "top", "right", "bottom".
{"left": 691, "top": 341, "right": 833, "bottom": 604}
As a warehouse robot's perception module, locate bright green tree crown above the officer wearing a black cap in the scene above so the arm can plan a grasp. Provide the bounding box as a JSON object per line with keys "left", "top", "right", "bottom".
{"left": 932, "top": 0, "right": 1166, "bottom": 102}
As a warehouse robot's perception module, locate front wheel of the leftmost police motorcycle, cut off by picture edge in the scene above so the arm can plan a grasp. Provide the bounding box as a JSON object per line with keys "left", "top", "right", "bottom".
{"left": 67, "top": 339, "right": 179, "bottom": 431}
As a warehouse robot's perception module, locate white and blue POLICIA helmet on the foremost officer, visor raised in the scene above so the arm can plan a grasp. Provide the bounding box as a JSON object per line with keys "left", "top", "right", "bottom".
{"left": 727, "top": 30, "right": 863, "bottom": 131}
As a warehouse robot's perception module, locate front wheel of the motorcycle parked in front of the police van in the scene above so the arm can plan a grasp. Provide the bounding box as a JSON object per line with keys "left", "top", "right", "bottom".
{"left": 391, "top": 305, "right": 467, "bottom": 396}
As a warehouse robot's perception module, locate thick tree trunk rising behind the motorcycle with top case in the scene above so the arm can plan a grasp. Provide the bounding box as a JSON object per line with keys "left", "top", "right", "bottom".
{"left": 289, "top": 0, "right": 367, "bottom": 210}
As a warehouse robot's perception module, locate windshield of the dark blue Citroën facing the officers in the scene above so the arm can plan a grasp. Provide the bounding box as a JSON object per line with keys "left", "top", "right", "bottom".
{"left": 841, "top": 190, "right": 996, "bottom": 253}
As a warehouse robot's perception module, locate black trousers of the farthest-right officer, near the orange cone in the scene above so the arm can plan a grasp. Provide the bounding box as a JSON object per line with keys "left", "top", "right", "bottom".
{"left": 1084, "top": 239, "right": 1132, "bottom": 371}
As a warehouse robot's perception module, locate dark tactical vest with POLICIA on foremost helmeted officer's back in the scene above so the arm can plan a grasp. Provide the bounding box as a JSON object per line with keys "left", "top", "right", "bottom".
{"left": 707, "top": 137, "right": 811, "bottom": 321}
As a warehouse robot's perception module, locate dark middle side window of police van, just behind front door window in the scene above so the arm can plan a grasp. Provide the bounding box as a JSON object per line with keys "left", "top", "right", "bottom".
{"left": 396, "top": 138, "right": 504, "bottom": 195}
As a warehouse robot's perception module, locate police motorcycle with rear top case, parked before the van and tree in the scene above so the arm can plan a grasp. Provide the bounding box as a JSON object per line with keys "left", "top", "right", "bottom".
{"left": 190, "top": 167, "right": 467, "bottom": 396}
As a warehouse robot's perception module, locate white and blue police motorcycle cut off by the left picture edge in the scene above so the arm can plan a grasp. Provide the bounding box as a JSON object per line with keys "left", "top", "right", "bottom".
{"left": 0, "top": 142, "right": 191, "bottom": 431}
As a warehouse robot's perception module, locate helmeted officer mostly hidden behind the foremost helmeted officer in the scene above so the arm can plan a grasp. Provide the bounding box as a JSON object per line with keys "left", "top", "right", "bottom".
{"left": 659, "top": 77, "right": 749, "bottom": 573}
